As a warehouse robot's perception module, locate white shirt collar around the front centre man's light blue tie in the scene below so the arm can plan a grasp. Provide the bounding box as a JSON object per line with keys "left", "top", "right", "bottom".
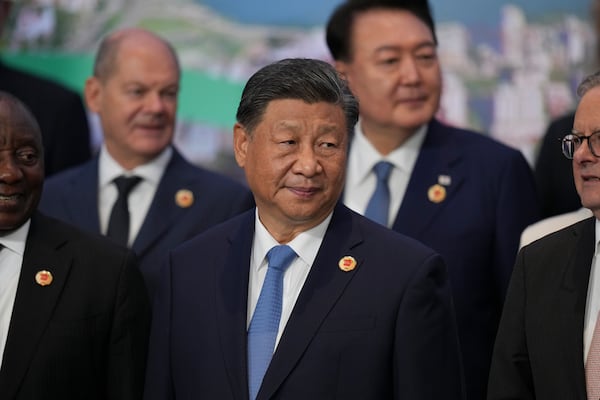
{"left": 252, "top": 208, "right": 333, "bottom": 269}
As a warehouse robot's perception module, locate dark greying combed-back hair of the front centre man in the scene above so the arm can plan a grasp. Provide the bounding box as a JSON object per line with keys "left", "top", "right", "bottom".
{"left": 236, "top": 58, "right": 358, "bottom": 135}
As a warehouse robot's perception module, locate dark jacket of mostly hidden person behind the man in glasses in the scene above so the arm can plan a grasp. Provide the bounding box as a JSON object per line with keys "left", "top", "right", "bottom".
{"left": 534, "top": 113, "right": 581, "bottom": 218}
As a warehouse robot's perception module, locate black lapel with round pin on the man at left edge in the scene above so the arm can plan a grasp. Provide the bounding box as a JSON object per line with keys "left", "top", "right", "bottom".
{"left": 0, "top": 214, "right": 72, "bottom": 398}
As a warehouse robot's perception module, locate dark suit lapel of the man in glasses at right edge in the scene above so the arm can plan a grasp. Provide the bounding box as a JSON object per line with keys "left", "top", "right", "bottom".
{"left": 557, "top": 218, "right": 595, "bottom": 398}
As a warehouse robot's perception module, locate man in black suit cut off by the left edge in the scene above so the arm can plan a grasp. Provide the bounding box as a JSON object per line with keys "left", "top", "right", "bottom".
{"left": 0, "top": 92, "right": 150, "bottom": 400}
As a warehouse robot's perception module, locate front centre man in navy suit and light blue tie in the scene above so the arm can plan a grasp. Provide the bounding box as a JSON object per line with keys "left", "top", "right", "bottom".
{"left": 145, "top": 59, "right": 463, "bottom": 400}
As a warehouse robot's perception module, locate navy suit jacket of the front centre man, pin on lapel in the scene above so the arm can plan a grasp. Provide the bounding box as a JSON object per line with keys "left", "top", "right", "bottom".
{"left": 145, "top": 205, "right": 462, "bottom": 400}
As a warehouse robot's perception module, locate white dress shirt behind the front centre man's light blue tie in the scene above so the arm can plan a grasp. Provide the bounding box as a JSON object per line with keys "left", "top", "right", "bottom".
{"left": 246, "top": 210, "right": 332, "bottom": 348}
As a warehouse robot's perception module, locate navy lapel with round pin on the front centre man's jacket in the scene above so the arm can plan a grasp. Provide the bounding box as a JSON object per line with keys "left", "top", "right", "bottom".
{"left": 258, "top": 204, "right": 362, "bottom": 399}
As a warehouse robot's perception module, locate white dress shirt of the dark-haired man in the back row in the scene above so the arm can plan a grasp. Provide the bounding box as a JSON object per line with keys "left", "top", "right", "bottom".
{"left": 344, "top": 120, "right": 427, "bottom": 226}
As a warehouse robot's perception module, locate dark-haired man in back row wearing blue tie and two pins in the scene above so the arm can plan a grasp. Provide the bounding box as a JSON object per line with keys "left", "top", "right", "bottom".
{"left": 327, "top": 0, "right": 538, "bottom": 400}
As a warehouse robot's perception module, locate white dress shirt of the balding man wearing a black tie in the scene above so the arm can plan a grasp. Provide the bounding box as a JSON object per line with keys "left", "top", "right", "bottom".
{"left": 98, "top": 145, "right": 173, "bottom": 246}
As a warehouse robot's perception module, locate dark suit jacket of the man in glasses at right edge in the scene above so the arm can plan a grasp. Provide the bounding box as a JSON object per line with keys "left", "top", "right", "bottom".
{"left": 488, "top": 218, "right": 595, "bottom": 400}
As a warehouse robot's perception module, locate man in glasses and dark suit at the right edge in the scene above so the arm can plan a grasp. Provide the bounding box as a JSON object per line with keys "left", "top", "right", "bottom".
{"left": 488, "top": 72, "right": 600, "bottom": 400}
